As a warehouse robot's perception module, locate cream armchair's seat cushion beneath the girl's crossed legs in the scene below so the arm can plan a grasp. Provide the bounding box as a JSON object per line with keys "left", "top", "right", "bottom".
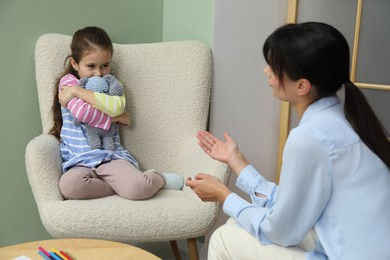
{"left": 41, "top": 190, "right": 218, "bottom": 242}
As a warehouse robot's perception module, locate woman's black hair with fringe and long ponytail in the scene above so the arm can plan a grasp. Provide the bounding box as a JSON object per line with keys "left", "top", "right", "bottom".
{"left": 263, "top": 22, "right": 390, "bottom": 168}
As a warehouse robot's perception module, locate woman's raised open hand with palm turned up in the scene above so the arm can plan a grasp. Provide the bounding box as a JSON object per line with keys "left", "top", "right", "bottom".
{"left": 196, "top": 131, "right": 249, "bottom": 175}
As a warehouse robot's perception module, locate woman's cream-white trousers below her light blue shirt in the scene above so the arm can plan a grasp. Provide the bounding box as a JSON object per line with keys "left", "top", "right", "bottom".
{"left": 207, "top": 218, "right": 317, "bottom": 260}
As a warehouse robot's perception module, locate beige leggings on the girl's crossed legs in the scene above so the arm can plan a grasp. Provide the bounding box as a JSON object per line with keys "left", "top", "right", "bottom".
{"left": 59, "top": 160, "right": 165, "bottom": 200}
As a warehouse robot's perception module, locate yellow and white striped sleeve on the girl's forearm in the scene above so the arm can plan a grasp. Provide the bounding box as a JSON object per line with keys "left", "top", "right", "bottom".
{"left": 94, "top": 92, "right": 126, "bottom": 117}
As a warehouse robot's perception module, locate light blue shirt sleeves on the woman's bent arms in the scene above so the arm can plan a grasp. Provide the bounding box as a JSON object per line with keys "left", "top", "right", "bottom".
{"left": 223, "top": 130, "right": 331, "bottom": 246}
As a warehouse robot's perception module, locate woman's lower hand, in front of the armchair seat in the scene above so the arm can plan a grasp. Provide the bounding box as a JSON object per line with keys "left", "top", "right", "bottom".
{"left": 186, "top": 173, "right": 231, "bottom": 203}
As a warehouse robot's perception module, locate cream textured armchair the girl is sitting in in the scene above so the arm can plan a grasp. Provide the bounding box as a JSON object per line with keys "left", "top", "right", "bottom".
{"left": 25, "top": 34, "right": 229, "bottom": 259}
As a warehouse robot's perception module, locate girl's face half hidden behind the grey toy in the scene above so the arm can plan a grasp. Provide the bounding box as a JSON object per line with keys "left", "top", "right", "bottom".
{"left": 70, "top": 48, "right": 112, "bottom": 78}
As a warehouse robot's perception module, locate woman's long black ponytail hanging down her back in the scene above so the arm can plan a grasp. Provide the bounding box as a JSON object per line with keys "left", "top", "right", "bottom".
{"left": 344, "top": 81, "right": 390, "bottom": 168}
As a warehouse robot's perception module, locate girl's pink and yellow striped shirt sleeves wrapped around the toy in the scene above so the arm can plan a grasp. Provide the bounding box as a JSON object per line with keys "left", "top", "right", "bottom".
{"left": 60, "top": 74, "right": 126, "bottom": 130}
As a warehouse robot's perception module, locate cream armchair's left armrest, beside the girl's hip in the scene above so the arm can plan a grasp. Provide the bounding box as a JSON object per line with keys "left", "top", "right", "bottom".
{"left": 25, "top": 134, "right": 64, "bottom": 205}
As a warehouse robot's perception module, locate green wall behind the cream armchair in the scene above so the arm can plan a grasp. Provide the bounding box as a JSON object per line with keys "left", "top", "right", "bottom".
{"left": 0, "top": 0, "right": 214, "bottom": 246}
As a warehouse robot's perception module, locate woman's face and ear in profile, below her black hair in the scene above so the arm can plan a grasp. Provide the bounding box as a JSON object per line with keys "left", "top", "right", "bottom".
{"left": 263, "top": 66, "right": 297, "bottom": 103}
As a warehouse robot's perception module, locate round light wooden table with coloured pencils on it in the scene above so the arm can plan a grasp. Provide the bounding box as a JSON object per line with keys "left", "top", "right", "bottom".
{"left": 0, "top": 239, "right": 160, "bottom": 260}
